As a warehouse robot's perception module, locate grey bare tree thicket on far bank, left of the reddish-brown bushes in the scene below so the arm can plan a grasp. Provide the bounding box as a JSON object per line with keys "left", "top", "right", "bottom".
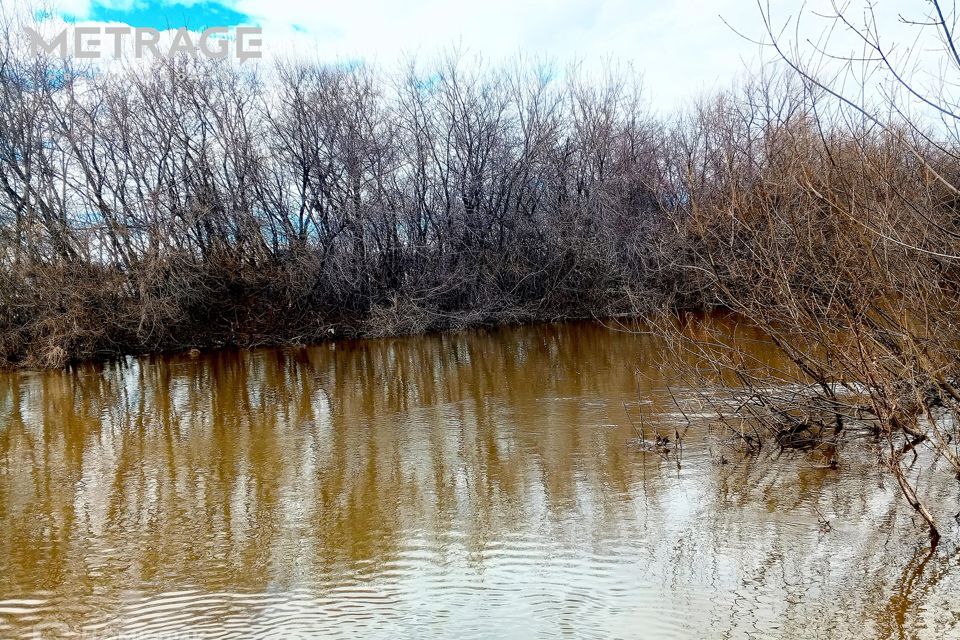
{"left": 0, "top": 51, "right": 688, "bottom": 366}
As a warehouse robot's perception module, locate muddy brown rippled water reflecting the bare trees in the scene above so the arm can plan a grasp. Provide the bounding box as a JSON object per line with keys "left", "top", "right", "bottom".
{"left": 0, "top": 323, "right": 960, "bottom": 639}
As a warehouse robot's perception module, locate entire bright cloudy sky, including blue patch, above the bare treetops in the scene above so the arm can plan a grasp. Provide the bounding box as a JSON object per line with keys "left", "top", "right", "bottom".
{"left": 5, "top": 0, "right": 928, "bottom": 108}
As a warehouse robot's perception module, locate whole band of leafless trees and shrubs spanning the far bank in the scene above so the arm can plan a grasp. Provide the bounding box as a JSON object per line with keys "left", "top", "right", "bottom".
{"left": 0, "top": 40, "right": 955, "bottom": 382}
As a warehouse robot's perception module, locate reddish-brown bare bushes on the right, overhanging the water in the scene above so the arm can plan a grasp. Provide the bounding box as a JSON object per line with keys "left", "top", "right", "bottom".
{"left": 662, "top": 88, "right": 960, "bottom": 543}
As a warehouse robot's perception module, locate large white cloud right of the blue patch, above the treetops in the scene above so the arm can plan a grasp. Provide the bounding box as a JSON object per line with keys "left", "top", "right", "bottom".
{"left": 223, "top": 0, "right": 760, "bottom": 105}
